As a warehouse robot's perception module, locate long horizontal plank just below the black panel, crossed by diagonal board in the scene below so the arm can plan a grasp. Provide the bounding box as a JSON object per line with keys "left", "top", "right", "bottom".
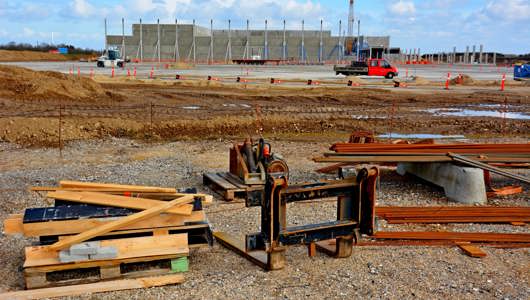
{"left": 22, "top": 210, "right": 206, "bottom": 236}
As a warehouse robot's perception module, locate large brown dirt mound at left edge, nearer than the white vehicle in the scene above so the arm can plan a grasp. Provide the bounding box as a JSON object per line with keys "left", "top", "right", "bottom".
{"left": 0, "top": 65, "right": 120, "bottom": 101}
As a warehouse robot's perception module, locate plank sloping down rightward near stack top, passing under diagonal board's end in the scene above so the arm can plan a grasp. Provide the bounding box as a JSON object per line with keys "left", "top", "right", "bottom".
{"left": 47, "top": 191, "right": 193, "bottom": 216}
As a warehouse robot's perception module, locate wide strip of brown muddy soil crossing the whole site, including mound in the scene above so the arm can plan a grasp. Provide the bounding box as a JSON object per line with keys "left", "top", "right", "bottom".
{"left": 0, "top": 67, "right": 530, "bottom": 146}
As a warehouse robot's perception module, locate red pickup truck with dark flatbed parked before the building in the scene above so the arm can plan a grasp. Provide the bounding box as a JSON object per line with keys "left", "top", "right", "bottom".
{"left": 333, "top": 59, "right": 399, "bottom": 79}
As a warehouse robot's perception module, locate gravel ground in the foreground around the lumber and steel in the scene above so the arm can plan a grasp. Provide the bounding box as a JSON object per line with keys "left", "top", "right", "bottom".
{"left": 0, "top": 139, "right": 530, "bottom": 299}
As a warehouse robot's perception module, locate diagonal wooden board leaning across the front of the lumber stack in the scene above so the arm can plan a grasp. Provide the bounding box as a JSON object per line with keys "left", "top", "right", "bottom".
{"left": 50, "top": 196, "right": 193, "bottom": 251}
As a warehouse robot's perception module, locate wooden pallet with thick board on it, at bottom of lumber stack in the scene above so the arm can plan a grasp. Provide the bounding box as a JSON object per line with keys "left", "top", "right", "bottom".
{"left": 24, "top": 234, "right": 189, "bottom": 289}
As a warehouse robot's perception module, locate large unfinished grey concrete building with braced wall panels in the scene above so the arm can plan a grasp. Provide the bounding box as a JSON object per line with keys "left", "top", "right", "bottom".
{"left": 106, "top": 23, "right": 390, "bottom": 63}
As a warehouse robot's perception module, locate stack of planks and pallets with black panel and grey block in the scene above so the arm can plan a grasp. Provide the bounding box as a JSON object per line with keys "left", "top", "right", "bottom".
{"left": 4, "top": 181, "right": 213, "bottom": 289}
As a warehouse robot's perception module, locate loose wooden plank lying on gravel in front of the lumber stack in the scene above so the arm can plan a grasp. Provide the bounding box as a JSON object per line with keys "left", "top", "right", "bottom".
{"left": 0, "top": 274, "right": 184, "bottom": 300}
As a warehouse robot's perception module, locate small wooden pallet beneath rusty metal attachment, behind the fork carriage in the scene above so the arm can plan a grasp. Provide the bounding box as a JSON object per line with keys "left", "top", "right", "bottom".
{"left": 202, "top": 172, "right": 264, "bottom": 201}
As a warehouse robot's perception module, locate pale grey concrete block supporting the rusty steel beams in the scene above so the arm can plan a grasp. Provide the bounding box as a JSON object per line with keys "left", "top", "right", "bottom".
{"left": 397, "top": 163, "right": 487, "bottom": 204}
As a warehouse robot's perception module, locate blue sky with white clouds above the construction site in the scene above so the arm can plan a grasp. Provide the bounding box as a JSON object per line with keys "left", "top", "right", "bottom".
{"left": 0, "top": 0, "right": 530, "bottom": 54}
